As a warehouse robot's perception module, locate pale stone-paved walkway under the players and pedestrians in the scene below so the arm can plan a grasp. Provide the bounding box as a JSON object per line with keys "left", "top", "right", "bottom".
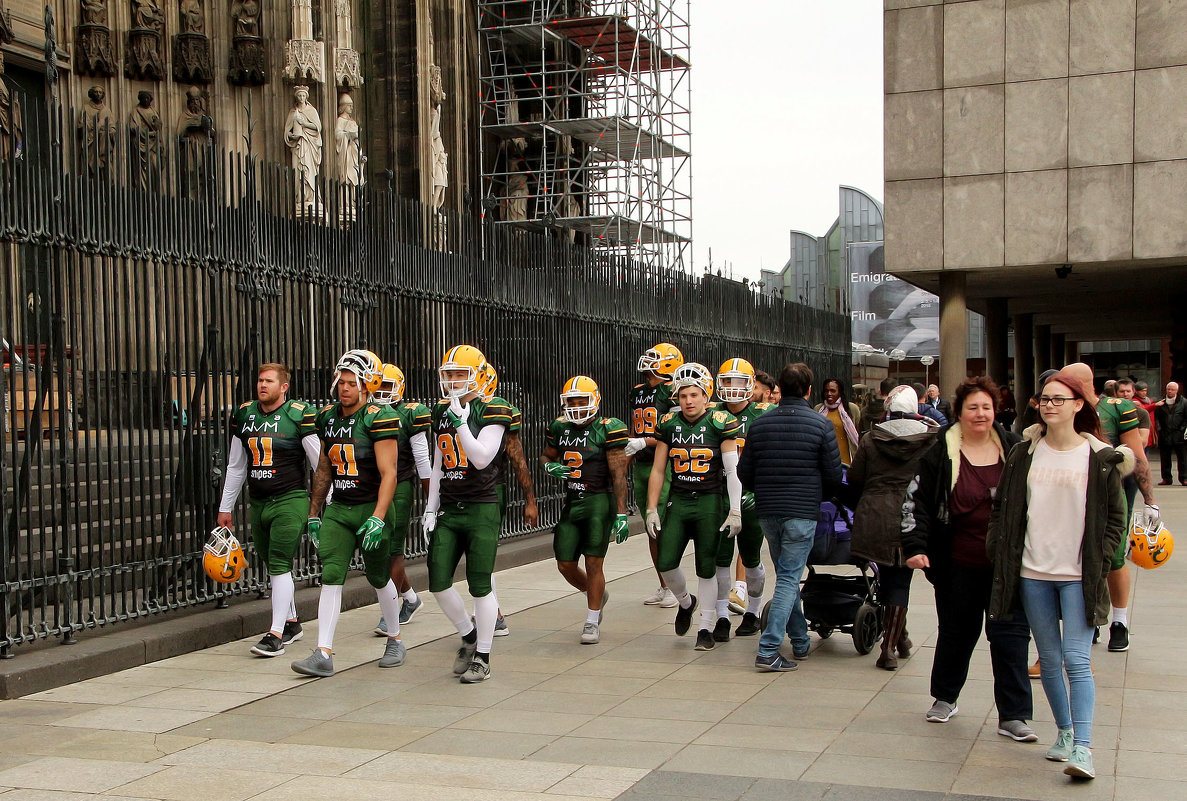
{"left": 0, "top": 488, "right": 1187, "bottom": 801}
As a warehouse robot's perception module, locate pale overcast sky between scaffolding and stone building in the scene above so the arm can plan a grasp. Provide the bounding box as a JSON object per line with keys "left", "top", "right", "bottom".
{"left": 691, "top": 0, "right": 883, "bottom": 279}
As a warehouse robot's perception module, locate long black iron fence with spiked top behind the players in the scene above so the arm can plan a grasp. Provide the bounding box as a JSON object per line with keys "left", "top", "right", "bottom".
{"left": 0, "top": 92, "right": 849, "bottom": 655}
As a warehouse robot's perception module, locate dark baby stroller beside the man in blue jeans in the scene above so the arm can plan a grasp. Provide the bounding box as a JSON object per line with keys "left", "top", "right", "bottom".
{"left": 762, "top": 500, "right": 882, "bottom": 655}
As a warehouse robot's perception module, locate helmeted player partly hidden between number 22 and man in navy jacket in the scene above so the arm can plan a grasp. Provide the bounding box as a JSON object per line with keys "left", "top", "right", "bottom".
{"left": 713, "top": 358, "right": 773, "bottom": 642}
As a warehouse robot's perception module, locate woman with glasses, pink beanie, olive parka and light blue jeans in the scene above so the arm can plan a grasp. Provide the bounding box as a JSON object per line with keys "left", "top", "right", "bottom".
{"left": 986, "top": 371, "right": 1134, "bottom": 778}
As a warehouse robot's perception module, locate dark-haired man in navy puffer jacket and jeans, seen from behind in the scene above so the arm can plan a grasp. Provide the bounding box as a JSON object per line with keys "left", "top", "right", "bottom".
{"left": 738, "top": 362, "right": 842, "bottom": 672}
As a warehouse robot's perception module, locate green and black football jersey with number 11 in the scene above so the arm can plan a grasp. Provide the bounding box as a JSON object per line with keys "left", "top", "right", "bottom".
{"left": 230, "top": 400, "right": 317, "bottom": 500}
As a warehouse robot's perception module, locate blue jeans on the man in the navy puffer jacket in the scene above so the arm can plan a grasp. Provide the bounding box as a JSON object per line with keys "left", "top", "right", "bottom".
{"left": 758, "top": 517, "right": 815, "bottom": 656}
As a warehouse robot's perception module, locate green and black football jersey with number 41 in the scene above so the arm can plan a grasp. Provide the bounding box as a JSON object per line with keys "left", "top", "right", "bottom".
{"left": 317, "top": 403, "right": 400, "bottom": 504}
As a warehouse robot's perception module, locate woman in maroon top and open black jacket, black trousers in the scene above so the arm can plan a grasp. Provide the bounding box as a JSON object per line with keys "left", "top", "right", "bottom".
{"left": 902, "top": 376, "right": 1039, "bottom": 743}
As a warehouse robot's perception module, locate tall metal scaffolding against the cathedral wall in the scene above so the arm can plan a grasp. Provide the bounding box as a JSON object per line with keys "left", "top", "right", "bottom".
{"left": 478, "top": 0, "right": 692, "bottom": 269}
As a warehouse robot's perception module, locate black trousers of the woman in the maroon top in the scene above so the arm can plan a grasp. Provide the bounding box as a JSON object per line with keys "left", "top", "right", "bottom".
{"left": 932, "top": 565, "right": 1034, "bottom": 720}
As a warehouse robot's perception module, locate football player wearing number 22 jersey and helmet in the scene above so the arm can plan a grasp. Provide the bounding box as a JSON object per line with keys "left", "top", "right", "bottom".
{"left": 645, "top": 362, "right": 742, "bottom": 650}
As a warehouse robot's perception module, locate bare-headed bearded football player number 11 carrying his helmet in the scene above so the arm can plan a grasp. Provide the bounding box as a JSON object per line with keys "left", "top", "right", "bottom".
{"left": 218, "top": 362, "right": 322, "bottom": 656}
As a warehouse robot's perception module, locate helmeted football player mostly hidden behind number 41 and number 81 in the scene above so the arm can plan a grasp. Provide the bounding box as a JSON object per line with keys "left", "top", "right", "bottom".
{"left": 372, "top": 364, "right": 432, "bottom": 637}
